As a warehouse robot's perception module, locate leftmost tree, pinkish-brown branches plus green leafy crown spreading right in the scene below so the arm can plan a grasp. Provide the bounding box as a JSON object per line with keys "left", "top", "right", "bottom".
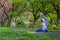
{"left": 0, "top": 0, "right": 26, "bottom": 27}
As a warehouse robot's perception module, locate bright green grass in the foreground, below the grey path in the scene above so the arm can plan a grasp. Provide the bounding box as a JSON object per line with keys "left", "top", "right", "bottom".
{"left": 0, "top": 27, "right": 59, "bottom": 40}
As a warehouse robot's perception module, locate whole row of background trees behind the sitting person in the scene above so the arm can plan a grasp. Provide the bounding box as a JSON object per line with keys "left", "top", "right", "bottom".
{"left": 0, "top": 0, "right": 60, "bottom": 29}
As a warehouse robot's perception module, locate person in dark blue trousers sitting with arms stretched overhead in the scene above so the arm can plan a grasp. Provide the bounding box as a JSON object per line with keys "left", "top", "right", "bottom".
{"left": 36, "top": 13, "right": 48, "bottom": 32}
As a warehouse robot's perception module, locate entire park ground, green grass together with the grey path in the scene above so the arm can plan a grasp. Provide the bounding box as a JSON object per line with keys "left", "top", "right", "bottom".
{"left": 0, "top": 27, "right": 60, "bottom": 40}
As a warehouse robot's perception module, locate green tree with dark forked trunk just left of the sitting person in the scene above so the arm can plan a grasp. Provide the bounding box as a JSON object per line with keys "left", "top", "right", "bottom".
{"left": 27, "top": 0, "right": 52, "bottom": 24}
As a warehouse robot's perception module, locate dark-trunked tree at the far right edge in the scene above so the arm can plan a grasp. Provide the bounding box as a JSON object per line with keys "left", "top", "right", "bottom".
{"left": 50, "top": 0, "right": 60, "bottom": 25}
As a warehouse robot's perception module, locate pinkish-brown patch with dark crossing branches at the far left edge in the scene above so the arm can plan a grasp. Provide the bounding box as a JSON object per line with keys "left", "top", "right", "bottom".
{"left": 0, "top": 0, "right": 11, "bottom": 26}
